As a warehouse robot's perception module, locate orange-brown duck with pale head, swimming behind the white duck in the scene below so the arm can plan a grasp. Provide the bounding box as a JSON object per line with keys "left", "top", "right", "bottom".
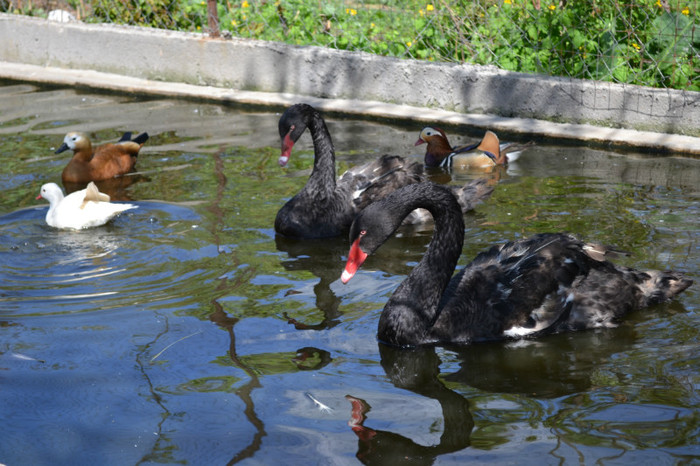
{"left": 56, "top": 132, "right": 148, "bottom": 185}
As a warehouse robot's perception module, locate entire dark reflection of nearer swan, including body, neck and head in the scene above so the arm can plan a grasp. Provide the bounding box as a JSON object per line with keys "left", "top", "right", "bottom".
{"left": 346, "top": 325, "right": 638, "bottom": 465}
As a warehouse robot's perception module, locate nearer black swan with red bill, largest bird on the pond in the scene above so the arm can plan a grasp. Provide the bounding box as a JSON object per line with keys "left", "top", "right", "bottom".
{"left": 342, "top": 183, "right": 692, "bottom": 346}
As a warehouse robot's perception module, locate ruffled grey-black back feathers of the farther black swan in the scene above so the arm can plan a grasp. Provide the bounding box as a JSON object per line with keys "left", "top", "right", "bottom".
{"left": 340, "top": 155, "right": 423, "bottom": 209}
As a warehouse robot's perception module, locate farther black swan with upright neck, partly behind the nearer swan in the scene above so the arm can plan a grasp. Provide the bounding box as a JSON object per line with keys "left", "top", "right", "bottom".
{"left": 275, "top": 104, "right": 493, "bottom": 238}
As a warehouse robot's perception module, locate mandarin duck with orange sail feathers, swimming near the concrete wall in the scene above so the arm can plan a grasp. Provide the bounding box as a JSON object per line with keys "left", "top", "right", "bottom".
{"left": 415, "top": 126, "right": 534, "bottom": 170}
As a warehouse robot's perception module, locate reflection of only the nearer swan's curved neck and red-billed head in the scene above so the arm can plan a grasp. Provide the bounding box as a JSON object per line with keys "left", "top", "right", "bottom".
{"left": 347, "top": 343, "right": 474, "bottom": 465}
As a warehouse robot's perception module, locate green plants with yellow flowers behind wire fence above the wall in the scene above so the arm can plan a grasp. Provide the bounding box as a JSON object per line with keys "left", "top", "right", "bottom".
{"left": 0, "top": 0, "right": 700, "bottom": 91}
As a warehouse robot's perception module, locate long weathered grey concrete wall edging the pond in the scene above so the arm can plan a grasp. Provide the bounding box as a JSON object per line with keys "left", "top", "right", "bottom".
{"left": 0, "top": 14, "right": 700, "bottom": 154}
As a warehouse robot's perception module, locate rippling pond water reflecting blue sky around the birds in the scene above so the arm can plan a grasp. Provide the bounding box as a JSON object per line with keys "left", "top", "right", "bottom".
{"left": 0, "top": 81, "right": 700, "bottom": 465}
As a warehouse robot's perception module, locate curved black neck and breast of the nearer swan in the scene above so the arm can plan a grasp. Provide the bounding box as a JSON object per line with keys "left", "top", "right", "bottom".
{"left": 378, "top": 185, "right": 464, "bottom": 346}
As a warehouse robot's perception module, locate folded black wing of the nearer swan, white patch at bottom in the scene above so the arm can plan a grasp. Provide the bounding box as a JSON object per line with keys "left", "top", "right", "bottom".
{"left": 440, "top": 234, "right": 590, "bottom": 341}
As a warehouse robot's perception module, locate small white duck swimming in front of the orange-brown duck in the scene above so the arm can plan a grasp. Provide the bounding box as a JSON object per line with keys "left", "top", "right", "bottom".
{"left": 36, "top": 182, "right": 136, "bottom": 230}
